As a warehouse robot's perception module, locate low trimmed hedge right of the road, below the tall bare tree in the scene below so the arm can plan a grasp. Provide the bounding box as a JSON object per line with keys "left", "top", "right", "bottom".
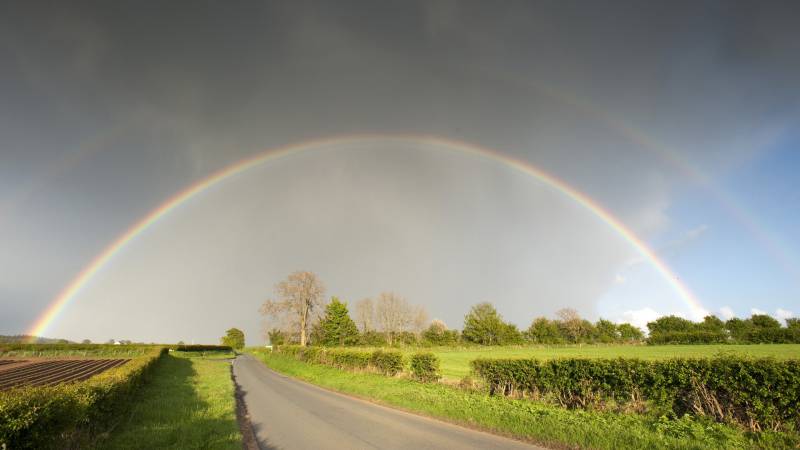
{"left": 273, "top": 345, "right": 403, "bottom": 377}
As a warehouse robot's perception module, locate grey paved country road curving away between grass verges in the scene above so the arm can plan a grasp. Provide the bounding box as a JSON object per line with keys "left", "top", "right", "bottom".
{"left": 233, "top": 355, "right": 537, "bottom": 450}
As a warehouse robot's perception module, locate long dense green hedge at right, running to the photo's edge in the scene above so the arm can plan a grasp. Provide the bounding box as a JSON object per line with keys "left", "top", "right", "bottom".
{"left": 472, "top": 357, "right": 800, "bottom": 431}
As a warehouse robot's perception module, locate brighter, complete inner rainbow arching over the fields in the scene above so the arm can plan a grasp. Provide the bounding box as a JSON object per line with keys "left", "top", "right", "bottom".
{"left": 27, "top": 134, "right": 707, "bottom": 336}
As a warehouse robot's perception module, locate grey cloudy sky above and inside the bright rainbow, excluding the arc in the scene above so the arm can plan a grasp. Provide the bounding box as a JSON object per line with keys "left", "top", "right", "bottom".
{"left": 0, "top": 1, "right": 800, "bottom": 342}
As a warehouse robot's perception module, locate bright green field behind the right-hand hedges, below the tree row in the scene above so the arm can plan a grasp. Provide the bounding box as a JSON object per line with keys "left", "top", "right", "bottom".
{"left": 418, "top": 344, "right": 800, "bottom": 380}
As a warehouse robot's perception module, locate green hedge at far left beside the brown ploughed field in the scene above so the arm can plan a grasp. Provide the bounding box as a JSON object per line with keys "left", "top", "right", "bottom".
{"left": 0, "top": 348, "right": 166, "bottom": 449}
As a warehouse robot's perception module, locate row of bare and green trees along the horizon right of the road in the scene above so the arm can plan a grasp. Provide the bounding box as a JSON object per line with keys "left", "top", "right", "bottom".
{"left": 261, "top": 272, "right": 800, "bottom": 346}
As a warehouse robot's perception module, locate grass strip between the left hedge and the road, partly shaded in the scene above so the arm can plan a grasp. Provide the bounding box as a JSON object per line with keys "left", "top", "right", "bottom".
{"left": 96, "top": 352, "right": 242, "bottom": 450}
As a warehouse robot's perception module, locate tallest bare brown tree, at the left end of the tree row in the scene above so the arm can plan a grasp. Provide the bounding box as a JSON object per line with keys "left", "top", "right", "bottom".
{"left": 261, "top": 271, "right": 325, "bottom": 346}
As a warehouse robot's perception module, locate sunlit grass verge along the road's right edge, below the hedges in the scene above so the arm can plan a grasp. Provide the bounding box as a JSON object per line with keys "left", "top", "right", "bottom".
{"left": 254, "top": 352, "right": 798, "bottom": 449}
